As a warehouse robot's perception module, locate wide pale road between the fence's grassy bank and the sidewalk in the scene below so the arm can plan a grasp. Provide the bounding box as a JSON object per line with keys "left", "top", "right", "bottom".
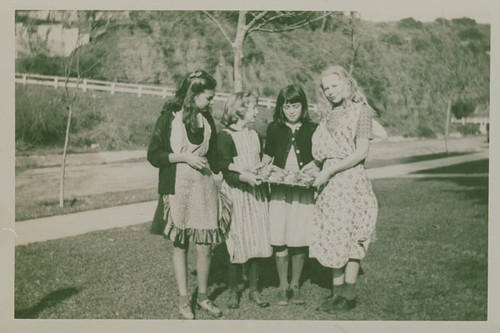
{"left": 15, "top": 136, "right": 487, "bottom": 202}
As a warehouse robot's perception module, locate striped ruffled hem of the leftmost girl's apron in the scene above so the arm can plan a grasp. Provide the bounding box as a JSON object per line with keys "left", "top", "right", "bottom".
{"left": 164, "top": 192, "right": 233, "bottom": 244}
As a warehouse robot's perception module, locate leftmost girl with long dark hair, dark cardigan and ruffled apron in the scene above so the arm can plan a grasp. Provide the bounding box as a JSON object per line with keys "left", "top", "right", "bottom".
{"left": 147, "top": 70, "right": 228, "bottom": 319}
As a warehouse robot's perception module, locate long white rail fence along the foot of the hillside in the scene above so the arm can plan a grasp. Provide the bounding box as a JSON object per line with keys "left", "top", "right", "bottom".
{"left": 15, "top": 73, "right": 317, "bottom": 112}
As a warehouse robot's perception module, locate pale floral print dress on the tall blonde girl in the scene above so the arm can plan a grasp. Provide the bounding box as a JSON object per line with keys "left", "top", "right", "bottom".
{"left": 309, "top": 102, "right": 378, "bottom": 268}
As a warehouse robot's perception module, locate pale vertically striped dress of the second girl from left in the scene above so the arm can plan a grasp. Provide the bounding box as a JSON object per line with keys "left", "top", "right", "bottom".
{"left": 221, "top": 129, "right": 272, "bottom": 264}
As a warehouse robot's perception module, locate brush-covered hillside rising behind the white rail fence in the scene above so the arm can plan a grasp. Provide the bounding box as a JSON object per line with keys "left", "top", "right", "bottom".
{"left": 16, "top": 11, "right": 490, "bottom": 149}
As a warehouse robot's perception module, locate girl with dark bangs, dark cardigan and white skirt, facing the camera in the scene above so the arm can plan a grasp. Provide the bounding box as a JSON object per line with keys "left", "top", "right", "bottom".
{"left": 259, "top": 84, "right": 319, "bottom": 306}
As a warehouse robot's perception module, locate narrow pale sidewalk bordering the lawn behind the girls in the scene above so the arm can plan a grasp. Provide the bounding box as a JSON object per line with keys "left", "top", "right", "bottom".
{"left": 15, "top": 151, "right": 488, "bottom": 245}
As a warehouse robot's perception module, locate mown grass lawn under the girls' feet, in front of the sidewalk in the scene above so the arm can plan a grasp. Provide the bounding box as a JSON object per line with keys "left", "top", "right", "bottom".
{"left": 15, "top": 177, "right": 488, "bottom": 321}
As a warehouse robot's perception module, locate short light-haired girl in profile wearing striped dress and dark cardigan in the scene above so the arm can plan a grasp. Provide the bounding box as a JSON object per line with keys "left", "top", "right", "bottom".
{"left": 213, "top": 92, "right": 272, "bottom": 309}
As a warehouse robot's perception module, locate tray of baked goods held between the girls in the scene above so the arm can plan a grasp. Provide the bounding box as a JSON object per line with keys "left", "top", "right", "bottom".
{"left": 256, "top": 165, "right": 314, "bottom": 187}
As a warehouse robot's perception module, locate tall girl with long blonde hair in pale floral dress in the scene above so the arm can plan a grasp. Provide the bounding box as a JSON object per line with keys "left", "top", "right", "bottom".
{"left": 309, "top": 66, "right": 378, "bottom": 312}
